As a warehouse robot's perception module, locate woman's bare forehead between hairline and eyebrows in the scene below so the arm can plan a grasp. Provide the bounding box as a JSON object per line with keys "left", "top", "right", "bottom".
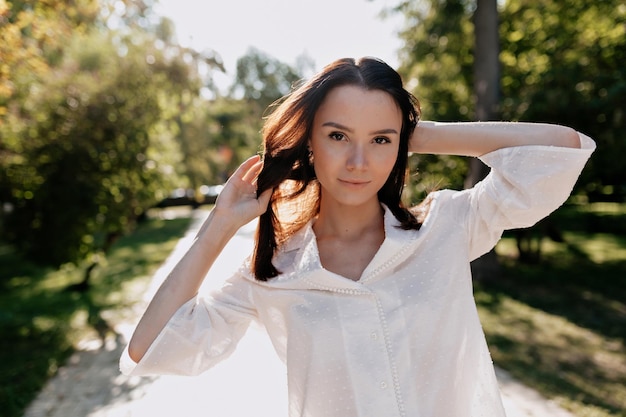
{"left": 315, "top": 85, "right": 402, "bottom": 125}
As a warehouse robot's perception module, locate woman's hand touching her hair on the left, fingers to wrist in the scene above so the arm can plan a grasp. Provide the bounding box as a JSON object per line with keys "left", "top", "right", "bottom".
{"left": 213, "top": 155, "right": 272, "bottom": 229}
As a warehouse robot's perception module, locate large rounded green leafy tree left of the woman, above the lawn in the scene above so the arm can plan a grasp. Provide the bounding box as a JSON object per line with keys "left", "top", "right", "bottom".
{"left": 0, "top": 0, "right": 224, "bottom": 284}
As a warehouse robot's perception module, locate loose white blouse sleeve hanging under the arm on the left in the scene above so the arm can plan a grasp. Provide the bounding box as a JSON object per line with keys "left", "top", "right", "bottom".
{"left": 120, "top": 274, "right": 257, "bottom": 375}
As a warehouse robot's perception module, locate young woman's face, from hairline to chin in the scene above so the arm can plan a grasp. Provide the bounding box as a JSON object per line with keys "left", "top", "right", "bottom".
{"left": 310, "top": 85, "right": 402, "bottom": 206}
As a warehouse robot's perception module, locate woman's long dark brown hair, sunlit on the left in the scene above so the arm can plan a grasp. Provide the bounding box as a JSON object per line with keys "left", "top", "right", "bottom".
{"left": 252, "top": 58, "right": 421, "bottom": 281}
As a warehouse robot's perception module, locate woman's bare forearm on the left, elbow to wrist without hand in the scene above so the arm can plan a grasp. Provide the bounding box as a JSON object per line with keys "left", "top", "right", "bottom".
{"left": 128, "top": 211, "right": 237, "bottom": 362}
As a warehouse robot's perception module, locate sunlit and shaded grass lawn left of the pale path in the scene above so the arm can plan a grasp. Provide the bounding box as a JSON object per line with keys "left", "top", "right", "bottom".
{"left": 0, "top": 211, "right": 189, "bottom": 417}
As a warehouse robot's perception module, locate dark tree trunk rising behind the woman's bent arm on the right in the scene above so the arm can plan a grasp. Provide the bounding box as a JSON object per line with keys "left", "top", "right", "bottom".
{"left": 465, "top": 0, "right": 500, "bottom": 281}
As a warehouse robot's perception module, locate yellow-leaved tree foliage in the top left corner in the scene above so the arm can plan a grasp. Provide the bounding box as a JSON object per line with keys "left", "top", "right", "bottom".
{"left": 0, "top": 0, "right": 99, "bottom": 244}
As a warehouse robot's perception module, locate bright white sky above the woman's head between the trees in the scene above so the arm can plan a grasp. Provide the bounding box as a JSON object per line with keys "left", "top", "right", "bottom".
{"left": 156, "top": 0, "right": 402, "bottom": 90}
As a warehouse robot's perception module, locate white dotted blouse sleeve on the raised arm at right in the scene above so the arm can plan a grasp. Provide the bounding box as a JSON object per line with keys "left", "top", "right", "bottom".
{"left": 457, "top": 133, "right": 595, "bottom": 259}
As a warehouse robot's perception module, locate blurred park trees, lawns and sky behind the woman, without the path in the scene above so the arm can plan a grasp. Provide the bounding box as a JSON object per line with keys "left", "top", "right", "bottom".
{"left": 0, "top": 0, "right": 626, "bottom": 417}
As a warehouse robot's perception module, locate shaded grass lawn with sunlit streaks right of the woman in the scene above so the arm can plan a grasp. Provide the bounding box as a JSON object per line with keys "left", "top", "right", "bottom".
{"left": 476, "top": 204, "right": 626, "bottom": 417}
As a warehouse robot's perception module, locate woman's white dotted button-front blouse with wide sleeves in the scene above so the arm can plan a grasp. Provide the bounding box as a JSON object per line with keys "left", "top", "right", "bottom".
{"left": 120, "top": 135, "right": 595, "bottom": 417}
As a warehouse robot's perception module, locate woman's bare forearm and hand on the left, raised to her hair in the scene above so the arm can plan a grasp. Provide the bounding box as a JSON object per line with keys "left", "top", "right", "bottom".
{"left": 128, "top": 156, "right": 271, "bottom": 362}
